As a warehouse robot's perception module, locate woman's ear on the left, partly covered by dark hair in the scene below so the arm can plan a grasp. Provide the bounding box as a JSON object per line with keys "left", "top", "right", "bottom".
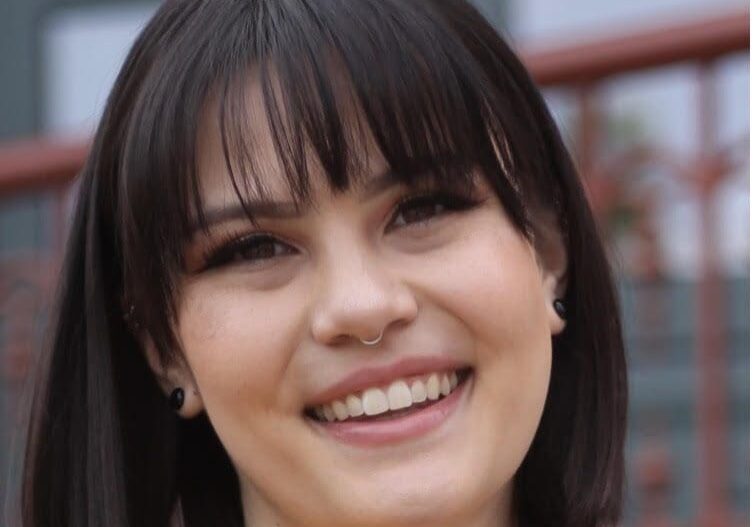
{"left": 141, "top": 337, "right": 204, "bottom": 419}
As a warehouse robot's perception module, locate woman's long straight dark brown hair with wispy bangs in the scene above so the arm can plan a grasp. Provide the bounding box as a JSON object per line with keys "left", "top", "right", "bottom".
{"left": 22, "top": 0, "right": 626, "bottom": 527}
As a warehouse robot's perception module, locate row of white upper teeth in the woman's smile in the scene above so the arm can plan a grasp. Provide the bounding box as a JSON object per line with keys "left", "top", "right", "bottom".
{"left": 314, "top": 372, "right": 459, "bottom": 423}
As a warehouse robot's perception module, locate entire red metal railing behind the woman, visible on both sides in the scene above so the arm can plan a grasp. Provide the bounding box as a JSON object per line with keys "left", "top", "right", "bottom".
{"left": 0, "top": 10, "right": 749, "bottom": 527}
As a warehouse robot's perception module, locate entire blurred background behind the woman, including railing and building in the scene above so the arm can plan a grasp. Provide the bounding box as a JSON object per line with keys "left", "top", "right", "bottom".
{"left": 0, "top": 0, "right": 750, "bottom": 527}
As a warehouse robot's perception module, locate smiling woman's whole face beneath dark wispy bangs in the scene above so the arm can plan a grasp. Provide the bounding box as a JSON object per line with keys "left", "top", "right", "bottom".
{"left": 164, "top": 80, "right": 562, "bottom": 526}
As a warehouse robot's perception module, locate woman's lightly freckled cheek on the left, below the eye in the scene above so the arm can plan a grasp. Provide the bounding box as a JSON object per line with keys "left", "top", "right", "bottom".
{"left": 179, "top": 280, "right": 302, "bottom": 420}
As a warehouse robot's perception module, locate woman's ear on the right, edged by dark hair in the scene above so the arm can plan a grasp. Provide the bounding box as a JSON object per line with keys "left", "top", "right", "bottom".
{"left": 533, "top": 211, "right": 568, "bottom": 336}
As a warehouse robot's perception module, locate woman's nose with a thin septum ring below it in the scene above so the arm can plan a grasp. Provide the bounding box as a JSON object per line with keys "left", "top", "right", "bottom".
{"left": 311, "top": 246, "right": 418, "bottom": 345}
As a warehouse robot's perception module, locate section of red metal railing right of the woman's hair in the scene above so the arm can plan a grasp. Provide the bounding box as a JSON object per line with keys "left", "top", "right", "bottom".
{"left": 527, "top": 10, "right": 749, "bottom": 527}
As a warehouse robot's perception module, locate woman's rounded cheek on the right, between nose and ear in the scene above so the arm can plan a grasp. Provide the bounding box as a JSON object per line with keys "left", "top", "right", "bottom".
{"left": 416, "top": 218, "right": 550, "bottom": 358}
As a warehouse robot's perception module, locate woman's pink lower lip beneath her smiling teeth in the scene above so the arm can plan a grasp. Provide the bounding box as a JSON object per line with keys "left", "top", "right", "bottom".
{"left": 306, "top": 375, "right": 473, "bottom": 447}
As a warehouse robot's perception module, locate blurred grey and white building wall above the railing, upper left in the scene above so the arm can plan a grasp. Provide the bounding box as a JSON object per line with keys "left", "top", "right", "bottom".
{"left": 0, "top": 0, "right": 157, "bottom": 140}
